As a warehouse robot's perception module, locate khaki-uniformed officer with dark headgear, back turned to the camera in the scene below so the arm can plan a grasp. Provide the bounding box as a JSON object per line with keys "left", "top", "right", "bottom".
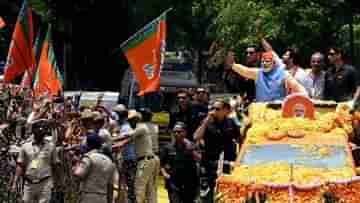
{"left": 74, "top": 133, "right": 115, "bottom": 203}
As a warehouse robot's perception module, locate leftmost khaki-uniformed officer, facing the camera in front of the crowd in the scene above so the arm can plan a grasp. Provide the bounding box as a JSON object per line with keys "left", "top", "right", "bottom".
{"left": 11, "top": 119, "right": 60, "bottom": 203}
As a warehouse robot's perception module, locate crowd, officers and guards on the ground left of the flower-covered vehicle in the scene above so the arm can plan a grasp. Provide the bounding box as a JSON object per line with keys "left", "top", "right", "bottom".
{"left": 1, "top": 80, "right": 245, "bottom": 203}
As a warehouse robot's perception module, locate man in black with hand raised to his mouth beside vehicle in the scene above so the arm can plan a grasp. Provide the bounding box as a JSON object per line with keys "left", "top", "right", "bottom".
{"left": 194, "top": 99, "right": 240, "bottom": 203}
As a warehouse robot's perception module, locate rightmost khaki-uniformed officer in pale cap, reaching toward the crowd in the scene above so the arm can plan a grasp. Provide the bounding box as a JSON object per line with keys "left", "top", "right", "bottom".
{"left": 121, "top": 110, "right": 158, "bottom": 203}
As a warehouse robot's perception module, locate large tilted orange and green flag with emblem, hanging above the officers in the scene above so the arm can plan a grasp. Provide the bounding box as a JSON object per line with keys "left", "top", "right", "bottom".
{"left": 121, "top": 13, "right": 166, "bottom": 96}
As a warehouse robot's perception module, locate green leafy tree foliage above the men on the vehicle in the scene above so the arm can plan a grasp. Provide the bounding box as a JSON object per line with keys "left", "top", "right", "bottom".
{"left": 212, "top": 0, "right": 358, "bottom": 68}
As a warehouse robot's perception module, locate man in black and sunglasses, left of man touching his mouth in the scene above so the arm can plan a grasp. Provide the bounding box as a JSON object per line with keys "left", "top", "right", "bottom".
{"left": 160, "top": 122, "right": 201, "bottom": 203}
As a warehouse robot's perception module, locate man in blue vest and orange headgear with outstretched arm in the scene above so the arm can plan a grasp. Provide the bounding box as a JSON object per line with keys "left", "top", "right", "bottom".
{"left": 225, "top": 51, "right": 307, "bottom": 102}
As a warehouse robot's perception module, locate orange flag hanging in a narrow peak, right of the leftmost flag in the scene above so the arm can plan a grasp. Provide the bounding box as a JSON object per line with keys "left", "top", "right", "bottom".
{"left": 33, "top": 29, "right": 63, "bottom": 98}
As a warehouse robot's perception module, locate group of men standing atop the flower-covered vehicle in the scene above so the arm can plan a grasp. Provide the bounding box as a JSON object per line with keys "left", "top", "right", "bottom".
{"left": 225, "top": 38, "right": 360, "bottom": 102}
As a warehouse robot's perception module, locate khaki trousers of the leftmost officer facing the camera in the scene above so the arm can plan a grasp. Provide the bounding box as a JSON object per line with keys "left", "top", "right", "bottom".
{"left": 23, "top": 178, "right": 53, "bottom": 203}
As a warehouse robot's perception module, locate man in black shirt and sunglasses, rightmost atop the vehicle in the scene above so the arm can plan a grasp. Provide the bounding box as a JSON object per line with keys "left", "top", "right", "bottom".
{"left": 324, "top": 48, "right": 359, "bottom": 102}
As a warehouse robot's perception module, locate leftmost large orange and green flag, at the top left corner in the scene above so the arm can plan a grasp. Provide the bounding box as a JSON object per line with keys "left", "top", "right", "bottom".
{"left": 4, "top": 0, "right": 35, "bottom": 83}
